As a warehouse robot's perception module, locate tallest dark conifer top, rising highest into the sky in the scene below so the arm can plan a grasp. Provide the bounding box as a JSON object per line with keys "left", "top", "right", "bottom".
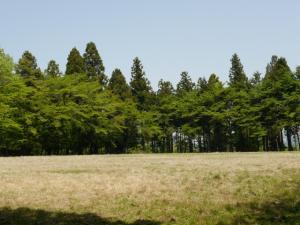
{"left": 83, "top": 42, "right": 107, "bottom": 85}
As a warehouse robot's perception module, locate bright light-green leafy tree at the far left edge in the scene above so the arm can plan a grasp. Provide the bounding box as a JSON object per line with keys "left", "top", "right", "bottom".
{"left": 0, "top": 74, "right": 34, "bottom": 155}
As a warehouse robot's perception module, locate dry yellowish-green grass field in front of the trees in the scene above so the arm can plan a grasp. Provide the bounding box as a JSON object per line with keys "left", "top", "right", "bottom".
{"left": 0, "top": 152, "right": 300, "bottom": 225}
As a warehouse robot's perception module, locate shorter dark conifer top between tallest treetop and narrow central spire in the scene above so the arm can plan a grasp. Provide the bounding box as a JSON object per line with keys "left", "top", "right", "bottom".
{"left": 108, "top": 69, "right": 131, "bottom": 100}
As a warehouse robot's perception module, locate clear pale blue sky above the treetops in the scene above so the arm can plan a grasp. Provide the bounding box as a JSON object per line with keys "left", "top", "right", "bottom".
{"left": 0, "top": 0, "right": 300, "bottom": 89}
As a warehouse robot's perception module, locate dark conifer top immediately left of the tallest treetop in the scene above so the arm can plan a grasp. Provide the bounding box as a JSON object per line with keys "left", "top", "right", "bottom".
{"left": 66, "top": 47, "right": 84, "bottom": 75}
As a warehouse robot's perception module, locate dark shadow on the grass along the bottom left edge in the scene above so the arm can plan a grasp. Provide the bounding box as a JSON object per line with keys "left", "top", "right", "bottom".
{"left": 0, "top": 208, "right": 160, "bottom": 225}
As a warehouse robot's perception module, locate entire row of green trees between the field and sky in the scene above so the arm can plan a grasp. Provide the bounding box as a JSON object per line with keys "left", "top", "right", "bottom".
{"left": 0, "top": 42, "right": 300, "bottom": 156}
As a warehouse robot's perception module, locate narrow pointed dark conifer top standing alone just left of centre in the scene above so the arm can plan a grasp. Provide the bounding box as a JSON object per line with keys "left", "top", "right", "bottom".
{"left": 130, "top": 57, "right": 152, "bottom": 110}
